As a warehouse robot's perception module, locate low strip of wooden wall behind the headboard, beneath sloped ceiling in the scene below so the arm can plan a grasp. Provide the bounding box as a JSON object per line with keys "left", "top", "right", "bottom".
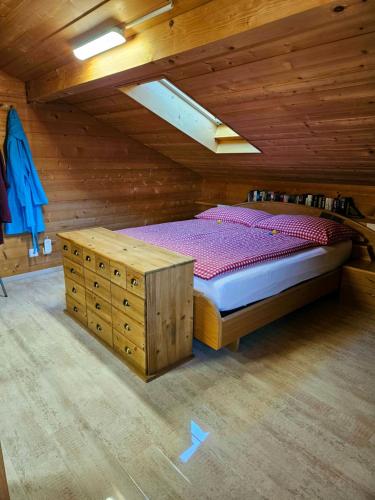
{"left": 200, "top": 177, "right": 375, "bottom": 215}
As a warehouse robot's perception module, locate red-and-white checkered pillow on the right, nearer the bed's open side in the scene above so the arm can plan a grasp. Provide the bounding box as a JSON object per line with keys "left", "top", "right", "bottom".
{"left": 255, "top": 215, "right": 354, "bottom": 245}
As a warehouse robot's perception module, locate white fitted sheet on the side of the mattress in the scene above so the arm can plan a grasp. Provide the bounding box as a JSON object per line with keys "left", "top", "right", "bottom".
{"left": 194, "top": 241, "right": 352, "bottom": 311}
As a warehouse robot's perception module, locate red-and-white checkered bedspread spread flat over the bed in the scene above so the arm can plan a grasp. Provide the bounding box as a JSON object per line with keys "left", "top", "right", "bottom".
{"left": 118, "top": 219, "right": 318, "bottom": 280}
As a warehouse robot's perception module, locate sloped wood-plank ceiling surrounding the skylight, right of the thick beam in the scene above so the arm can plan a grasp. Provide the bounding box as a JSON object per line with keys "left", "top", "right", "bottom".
{"left": 38, "top": 2, "right": 375, "bottom": 188}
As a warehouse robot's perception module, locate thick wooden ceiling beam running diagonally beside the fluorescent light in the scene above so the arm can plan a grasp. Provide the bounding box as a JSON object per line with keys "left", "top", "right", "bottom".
{"left": 27, "top": 0, "right": 334, "bottom": 102}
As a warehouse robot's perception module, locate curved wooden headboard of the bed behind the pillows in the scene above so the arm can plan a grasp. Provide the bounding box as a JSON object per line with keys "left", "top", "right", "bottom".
{"left": 236, "top": 201, "right": 375, "bottom": 259}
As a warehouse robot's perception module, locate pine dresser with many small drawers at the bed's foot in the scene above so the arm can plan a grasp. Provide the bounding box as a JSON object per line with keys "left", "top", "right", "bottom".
{"left": 58, "top": 228, "right": 194, "bottom": 381}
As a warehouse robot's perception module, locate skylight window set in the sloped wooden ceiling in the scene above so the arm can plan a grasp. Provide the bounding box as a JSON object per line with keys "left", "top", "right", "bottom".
{"left": 119, "top": 78, "right": 260, "bottom": 153}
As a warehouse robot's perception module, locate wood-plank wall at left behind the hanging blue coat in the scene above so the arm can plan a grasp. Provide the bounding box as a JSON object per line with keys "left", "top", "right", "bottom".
{"left": 0, "top": 72, "right": 199, "bottom": 276}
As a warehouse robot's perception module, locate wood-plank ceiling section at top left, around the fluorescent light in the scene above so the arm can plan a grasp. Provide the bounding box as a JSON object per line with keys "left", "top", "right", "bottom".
{"left": 0, "top": 0, "right": 212, "bottom": 80}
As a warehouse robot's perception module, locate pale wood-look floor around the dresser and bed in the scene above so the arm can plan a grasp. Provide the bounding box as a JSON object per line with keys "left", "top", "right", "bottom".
{"left": 0, "top": 271, "right": 375, "bottom": 500}
